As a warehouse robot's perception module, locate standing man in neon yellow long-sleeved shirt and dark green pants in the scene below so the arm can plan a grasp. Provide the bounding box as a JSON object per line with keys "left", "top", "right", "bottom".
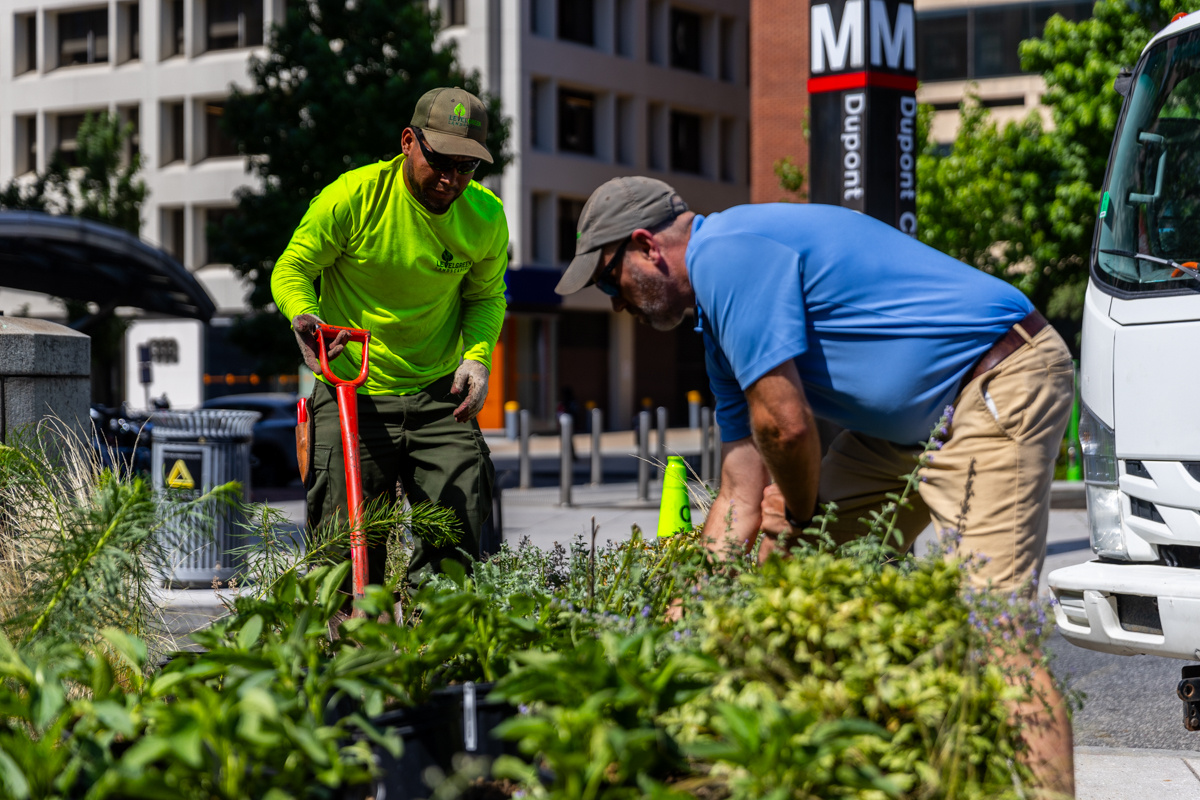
{"left": 271, "top": 88, "right": 509, "bottom": 583}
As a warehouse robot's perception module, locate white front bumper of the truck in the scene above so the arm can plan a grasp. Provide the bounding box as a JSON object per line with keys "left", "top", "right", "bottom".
{"left": 1046, "top": 561, "right": 1200, "bottom": 661}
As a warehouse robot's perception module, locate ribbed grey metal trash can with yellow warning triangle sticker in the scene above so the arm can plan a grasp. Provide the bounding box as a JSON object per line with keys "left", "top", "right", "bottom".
{"left": 150, "top": 409, "right": 262, "bottom": 587}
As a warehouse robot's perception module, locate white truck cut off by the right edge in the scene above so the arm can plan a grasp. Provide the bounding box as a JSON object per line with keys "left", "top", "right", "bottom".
{"left": 1048, "top": 13, "right": 1200, "bottom": 730}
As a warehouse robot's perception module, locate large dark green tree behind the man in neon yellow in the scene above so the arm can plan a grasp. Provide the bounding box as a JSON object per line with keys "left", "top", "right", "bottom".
{"left": 209, "top": 0, "right": 510, "bottom": 374}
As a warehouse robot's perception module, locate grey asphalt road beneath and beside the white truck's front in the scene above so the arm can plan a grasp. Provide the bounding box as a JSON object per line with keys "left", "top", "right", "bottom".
{"left": 1045, "top": 510, "right": 1200, "bottom": 752}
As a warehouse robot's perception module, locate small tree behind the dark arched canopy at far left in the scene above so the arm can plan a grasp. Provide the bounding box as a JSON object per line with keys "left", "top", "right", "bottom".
{"left": 0, "top": 113, "right": 146, "bottom": 405}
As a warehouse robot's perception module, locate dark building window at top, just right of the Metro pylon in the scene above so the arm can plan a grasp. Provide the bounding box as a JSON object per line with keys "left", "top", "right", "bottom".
{"left": 917, "top": 1, "right": 1092, "bottom": 80}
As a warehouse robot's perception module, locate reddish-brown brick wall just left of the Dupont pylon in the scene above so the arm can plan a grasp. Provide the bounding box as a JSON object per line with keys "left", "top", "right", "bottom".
{"left": 750, "top": 0, "right": 809, "bottom": 203}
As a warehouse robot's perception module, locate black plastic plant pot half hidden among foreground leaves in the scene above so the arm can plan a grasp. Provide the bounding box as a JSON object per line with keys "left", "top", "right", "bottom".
{"left": 364, "top": 681, "right": 517, "bottom": 800}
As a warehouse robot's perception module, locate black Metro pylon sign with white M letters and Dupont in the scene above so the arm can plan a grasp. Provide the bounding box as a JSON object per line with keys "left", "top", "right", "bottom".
{"left": 809, "top": 0, "right": 917, "bottom": 236}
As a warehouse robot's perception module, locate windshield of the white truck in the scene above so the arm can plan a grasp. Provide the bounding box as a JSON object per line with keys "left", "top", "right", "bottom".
{"left": 1096, "top": 31, "right": 1200, "bottom": 293}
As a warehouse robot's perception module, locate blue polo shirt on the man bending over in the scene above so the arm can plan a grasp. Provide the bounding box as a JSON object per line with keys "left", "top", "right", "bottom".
{"left": 686, "top": 203, "right": 1033, "bottom": 444}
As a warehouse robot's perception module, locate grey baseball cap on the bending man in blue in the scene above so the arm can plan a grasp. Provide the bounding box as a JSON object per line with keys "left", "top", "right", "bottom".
{"left": 554, "top": 176, "right": 688, "bottom": 294}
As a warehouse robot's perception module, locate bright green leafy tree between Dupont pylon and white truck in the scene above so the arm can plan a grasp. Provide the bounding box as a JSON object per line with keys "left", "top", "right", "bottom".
{"left": 917, "top": 0, "right": 1200, "bottom": 347}
